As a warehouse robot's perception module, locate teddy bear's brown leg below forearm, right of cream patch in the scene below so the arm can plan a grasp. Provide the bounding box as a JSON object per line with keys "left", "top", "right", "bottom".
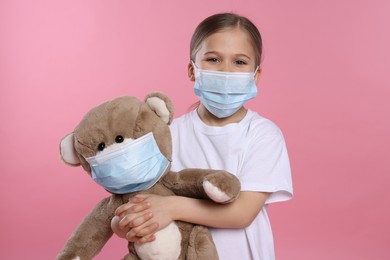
{"left": 186, "top": 225, "right": 219, "bottom": 260}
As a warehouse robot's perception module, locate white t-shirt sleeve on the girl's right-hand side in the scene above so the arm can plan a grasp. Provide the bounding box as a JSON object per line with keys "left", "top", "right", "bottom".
{"left": 239, "top": 126, "right": 293, "bottom": 204}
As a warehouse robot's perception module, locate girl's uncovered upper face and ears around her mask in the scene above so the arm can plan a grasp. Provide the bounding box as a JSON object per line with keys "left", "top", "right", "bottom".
{"left": 188, "top": 28, "right": 260, "bottom": 81}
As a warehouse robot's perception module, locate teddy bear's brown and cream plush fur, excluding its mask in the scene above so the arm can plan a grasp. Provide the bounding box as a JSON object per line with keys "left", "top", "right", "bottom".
{"left": 57, "top": 93, "right": 240, "bottom": 260}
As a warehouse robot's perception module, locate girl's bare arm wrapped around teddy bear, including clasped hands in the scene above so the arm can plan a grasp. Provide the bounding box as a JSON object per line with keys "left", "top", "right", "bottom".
{"left": 116, "top": 191, "right": 269, "bottom": 243}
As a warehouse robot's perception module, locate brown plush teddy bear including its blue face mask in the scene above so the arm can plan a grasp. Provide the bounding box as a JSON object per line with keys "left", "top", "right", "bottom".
{"left": 57, "top": 93, "right": 240, "bottom": 260}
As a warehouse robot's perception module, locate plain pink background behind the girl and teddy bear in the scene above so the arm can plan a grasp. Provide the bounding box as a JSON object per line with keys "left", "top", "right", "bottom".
{"left": 0, "top": 0, "right": 390, "bottom": 260}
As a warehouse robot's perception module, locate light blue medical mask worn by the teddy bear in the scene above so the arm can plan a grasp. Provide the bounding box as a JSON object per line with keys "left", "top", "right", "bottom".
{"left": 86, "top": 132, "right": 169, "bottom": 194}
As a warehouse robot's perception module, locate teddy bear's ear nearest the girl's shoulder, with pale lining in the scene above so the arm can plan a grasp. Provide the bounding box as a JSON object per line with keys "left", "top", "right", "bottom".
{"left": 145, "top": 92, "right": 174, "bottom": 125}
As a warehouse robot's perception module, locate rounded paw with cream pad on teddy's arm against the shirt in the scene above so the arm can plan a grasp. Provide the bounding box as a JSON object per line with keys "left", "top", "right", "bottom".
{"left": 203, "top": 171, "right": 241, "bottom": 203}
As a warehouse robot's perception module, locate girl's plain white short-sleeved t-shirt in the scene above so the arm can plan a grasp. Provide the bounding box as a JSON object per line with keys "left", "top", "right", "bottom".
{"left": 171, "top": 110, "right": 293, "bottom": 260}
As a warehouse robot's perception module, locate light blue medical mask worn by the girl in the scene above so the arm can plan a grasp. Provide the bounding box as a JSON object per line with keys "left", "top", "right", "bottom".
{"left": 192, "top": 62, "right": 258, "bottom": 118}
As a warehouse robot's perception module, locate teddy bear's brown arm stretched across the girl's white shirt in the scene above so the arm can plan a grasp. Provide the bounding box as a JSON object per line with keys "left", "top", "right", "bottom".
{"left": 162, "top": 168, "right": 241, "bottom": 203}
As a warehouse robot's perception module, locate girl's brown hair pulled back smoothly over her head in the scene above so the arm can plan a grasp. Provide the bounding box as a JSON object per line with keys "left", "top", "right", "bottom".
{"left": 190, "top": 13, "right": 263, "bottom": 67}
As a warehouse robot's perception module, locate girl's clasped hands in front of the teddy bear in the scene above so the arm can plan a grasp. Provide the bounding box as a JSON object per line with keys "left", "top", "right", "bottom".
{"left": 113, "top": 194, "right": 174, "bottom": 243}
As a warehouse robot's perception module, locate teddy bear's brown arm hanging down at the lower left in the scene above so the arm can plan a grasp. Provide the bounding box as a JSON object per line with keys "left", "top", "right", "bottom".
{"left": 56, "top": 196, "right": 122, "bottom": 260}
